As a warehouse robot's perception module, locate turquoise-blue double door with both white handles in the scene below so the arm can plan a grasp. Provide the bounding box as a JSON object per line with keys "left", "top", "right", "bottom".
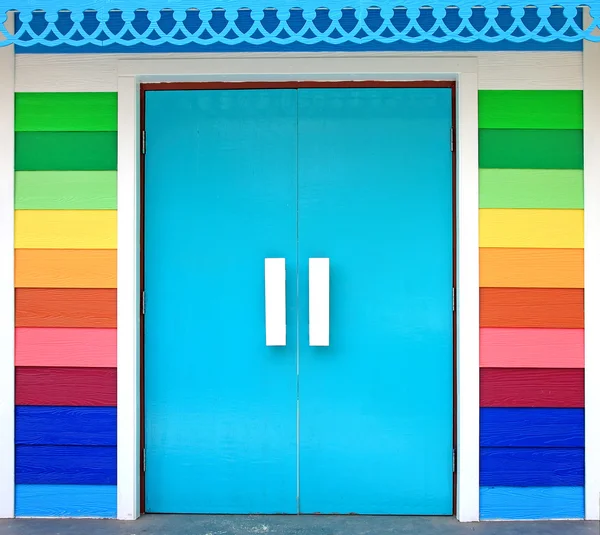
{"left": 144, "top": 88, "right": 453, "bottom": 514}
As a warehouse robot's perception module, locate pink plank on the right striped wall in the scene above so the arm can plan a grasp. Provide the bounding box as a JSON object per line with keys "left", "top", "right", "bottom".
{"left": 479, "top": 328, "right": 584, "bottom": 368}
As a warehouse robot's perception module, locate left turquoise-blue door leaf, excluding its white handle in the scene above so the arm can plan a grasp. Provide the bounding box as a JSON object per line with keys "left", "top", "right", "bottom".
{"left": 145, "top": 90, "right": 297, "bottom": 513}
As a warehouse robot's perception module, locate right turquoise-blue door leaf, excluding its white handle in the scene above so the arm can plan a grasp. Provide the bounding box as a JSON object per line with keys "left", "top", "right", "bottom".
{"left": 298, "top": 88, "right": 453, "bottom": 515}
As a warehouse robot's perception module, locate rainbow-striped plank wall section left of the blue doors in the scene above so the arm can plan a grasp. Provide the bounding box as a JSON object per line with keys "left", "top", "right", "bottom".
{"left": 15, "top": 93, "right": 117, "bottom": 517}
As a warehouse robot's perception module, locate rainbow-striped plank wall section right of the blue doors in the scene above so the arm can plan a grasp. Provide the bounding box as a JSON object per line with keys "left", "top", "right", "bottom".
{"left": 479, "top": 91, "right": 584, "bottom": 520}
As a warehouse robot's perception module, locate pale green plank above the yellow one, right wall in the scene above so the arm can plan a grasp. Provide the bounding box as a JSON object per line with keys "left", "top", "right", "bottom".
{"left": 479, "top": 169, "right": 583, "bottom": 209}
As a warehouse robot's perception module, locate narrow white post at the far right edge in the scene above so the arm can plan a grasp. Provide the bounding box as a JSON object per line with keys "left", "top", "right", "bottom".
{"left": 583, "top": 9, "right": 600, "bottom": 520}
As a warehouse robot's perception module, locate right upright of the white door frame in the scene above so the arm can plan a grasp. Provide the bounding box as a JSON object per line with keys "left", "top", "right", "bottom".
{"left": 456, "top": 68, "right": 479, "bottom": 522}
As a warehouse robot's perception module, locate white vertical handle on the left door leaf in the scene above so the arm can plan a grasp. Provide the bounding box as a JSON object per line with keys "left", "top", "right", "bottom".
{"left": 265, "top": 258, "right": 286, "bottom": 346}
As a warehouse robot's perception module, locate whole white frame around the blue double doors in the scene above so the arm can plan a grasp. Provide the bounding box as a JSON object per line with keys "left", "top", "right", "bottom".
{"left": 117, "top": 54, "right": 479, "bottom": 522}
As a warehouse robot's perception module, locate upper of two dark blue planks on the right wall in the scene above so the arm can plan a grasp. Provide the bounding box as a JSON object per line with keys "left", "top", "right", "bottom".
{"left": 480, "top": 408, "right": 584, "bottom": 448}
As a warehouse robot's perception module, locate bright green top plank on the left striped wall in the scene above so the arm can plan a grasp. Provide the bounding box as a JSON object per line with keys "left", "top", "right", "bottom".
{"left": 15, "top": 93, "right": 117, "bottom": 132}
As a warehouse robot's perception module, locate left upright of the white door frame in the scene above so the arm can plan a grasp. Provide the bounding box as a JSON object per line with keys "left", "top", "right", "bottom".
{"left": 117, "top": 76, "right": 140, "bottom": 520}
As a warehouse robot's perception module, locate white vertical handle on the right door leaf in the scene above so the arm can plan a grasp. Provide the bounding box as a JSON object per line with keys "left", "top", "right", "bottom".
{"left": 308, "top": 258, "right": 329, "bottom": 346}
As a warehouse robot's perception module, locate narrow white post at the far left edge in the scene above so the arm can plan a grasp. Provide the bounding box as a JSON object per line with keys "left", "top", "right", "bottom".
{"left": 0, "top": 13, "right": 15, "bottom": 518}
